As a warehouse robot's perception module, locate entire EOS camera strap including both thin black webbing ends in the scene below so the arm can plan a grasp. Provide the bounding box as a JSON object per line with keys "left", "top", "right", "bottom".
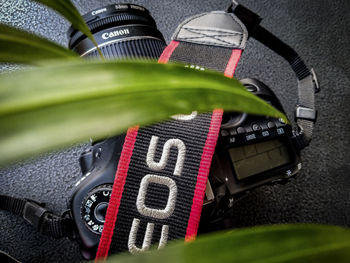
{"left": 0, "top": 1, "right": 320, "bottom": 259}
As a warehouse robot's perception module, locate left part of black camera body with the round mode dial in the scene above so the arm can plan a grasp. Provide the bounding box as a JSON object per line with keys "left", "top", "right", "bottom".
{"left": 69, "top": 136, "right": 124, "bottom": 259}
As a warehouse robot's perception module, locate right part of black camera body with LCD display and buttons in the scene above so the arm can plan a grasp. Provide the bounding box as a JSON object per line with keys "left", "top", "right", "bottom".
{"left": 200, "top": 79, "right": 301, "bottom": 227}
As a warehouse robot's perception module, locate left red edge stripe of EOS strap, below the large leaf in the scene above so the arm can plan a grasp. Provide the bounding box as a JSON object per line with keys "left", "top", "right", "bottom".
{"left": 95, "top": 126, "right": 139, "bottom": 262}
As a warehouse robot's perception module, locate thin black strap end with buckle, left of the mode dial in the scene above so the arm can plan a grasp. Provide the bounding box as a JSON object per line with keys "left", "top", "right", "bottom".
{"left": 0, "top": 195, "right": 74, "bottom": 238}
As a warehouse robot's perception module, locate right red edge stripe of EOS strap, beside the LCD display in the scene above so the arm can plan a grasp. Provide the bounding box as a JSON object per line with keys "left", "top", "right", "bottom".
{"left": 185, "top": 109, "right": 224, "bottom": 241}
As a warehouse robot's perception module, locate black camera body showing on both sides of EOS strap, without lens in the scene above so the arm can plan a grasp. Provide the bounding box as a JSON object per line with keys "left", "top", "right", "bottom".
{"left": 70, "top": 79, "right": 301, "bottom": 258}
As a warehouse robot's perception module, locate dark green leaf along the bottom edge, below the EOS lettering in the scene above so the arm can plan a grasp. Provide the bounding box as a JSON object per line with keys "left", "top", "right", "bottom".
{"left": 107, "top": 225, "right": 350, "bottom": 263}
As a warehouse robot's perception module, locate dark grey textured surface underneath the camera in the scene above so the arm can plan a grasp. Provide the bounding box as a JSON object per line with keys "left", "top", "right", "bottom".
{"left": 0, "top": 0, "right": 350, "bottom": 262}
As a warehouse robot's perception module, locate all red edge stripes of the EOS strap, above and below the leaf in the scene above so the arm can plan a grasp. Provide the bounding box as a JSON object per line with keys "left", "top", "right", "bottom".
{"left": 96, "top": 40, "right": 242, "bottom": 261}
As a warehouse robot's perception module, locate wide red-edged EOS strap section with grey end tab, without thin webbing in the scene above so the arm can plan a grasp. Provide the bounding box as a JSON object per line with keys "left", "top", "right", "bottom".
{"left": 96, "top": 12, "right": 248, "bottom": 260}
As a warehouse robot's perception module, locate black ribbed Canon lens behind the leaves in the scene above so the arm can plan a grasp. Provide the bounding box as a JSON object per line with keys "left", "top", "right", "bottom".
{"left": 68, "top": 4, "right": 166, "bottom": 59}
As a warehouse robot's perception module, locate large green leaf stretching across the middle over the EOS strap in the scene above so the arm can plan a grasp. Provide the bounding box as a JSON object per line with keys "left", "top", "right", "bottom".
{"left": 0, "top": 61, "right": 285, "bottom": 164}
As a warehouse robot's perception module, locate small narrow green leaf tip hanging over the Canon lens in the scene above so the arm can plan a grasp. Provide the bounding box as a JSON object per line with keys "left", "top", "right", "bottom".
{"left": 33, "top": 0, "right": 103, "bottom": 58}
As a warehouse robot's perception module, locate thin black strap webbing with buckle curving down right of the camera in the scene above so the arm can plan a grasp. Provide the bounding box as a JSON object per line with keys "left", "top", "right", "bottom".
{"left": 227, "top": 0, "right": 320, "bottom": 149}
